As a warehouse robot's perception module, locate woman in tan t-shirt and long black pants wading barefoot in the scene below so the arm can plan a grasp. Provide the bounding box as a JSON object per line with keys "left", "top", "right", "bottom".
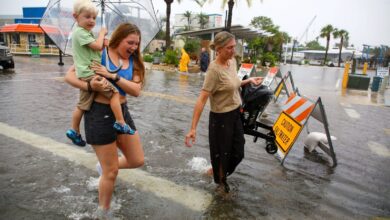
{"left": 185, "top": 31, "right": 263, "bottom": 192}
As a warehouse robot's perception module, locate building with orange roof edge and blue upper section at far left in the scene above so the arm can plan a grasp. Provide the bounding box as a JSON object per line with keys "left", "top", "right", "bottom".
{"left": 0, "top": 7, "right": 59, "bottom": 55}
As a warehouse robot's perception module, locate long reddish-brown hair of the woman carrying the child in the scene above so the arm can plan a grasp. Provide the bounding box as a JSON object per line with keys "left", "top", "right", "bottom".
{"left": 108, "top": 22, "right": 145, "bottom": 85}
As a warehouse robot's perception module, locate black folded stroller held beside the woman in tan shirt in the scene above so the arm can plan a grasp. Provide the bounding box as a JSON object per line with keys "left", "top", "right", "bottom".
{"left": 241, "top": 76, "right": 278, "bottom": 154}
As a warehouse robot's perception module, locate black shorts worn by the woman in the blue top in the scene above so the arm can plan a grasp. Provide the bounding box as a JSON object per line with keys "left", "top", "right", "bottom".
{"left": 84, "top": 102, "right": 137, "bottom": 145}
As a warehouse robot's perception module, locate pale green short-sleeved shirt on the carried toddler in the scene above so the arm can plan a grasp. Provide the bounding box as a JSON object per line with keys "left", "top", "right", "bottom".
{"left": 72, "top": 26, "right": 101, "bottom": 78}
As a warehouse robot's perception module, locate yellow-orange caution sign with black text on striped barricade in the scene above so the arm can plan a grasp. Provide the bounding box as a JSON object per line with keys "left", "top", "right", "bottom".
{"left": 272, "top": 112, "right": 302, "bottom": 153}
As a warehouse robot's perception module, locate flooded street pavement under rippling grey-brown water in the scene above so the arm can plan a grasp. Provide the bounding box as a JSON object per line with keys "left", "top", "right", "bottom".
{"left": 0, "top": 56, "right": 390, "bottom": 219}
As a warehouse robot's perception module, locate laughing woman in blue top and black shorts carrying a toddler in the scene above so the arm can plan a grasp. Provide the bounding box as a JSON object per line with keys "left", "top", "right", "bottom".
{"left": 65, "top": 23, "right": 145, "bottom": 219}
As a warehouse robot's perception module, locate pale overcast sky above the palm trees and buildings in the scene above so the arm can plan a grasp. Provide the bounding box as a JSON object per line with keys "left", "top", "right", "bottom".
{"left": 0, "top": 0, "right": 390, "bottom": 49}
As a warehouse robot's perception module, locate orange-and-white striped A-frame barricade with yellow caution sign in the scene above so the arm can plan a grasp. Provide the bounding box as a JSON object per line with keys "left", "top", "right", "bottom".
{"left": 273, "top": 93, "right": 337, "bottom": 166}
